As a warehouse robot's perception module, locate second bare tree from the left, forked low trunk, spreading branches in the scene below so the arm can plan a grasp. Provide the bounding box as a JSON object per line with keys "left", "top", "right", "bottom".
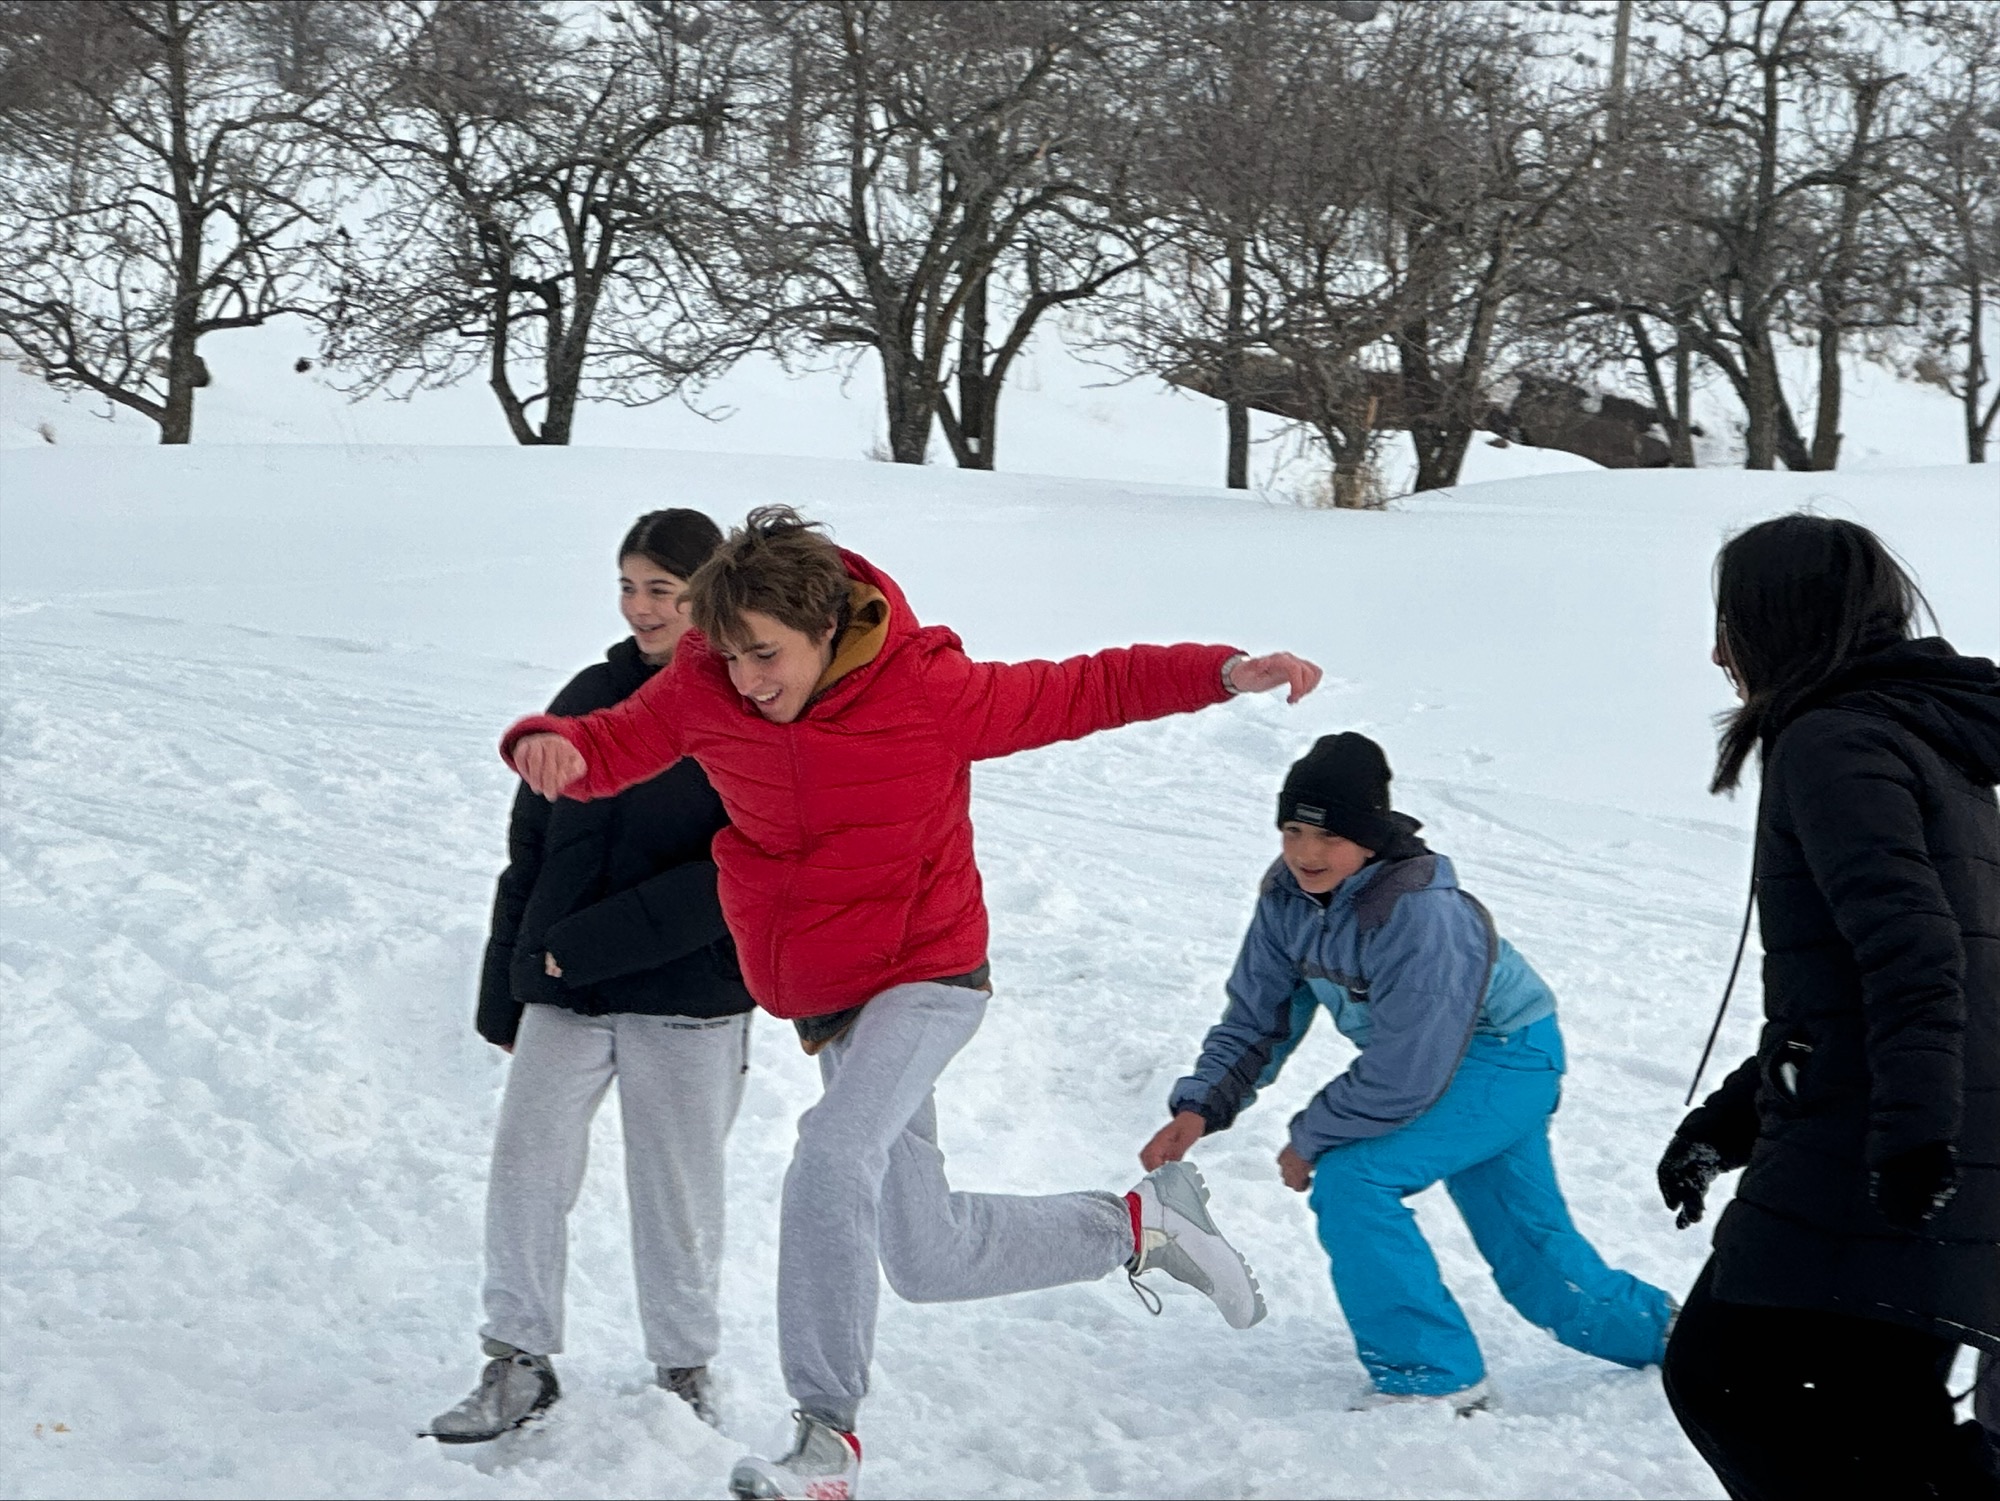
{"left": 328, "top": 0, "right": 760, "bottom": 444}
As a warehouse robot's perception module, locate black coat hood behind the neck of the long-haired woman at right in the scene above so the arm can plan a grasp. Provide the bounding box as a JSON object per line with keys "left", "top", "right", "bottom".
{"left": 1810, "top": 636, "right": 2000, "bottom": 787}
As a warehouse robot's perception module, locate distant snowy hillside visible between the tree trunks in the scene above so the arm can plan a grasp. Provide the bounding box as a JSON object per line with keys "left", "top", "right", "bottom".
{"left": 0, "top": 320, "right": 1964, "bottom": 494}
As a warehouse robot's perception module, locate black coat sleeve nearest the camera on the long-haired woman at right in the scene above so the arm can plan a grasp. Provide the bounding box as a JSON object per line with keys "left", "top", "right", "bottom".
{"left": 1768, "top": 710, "right": 1966, "bottom": 1167}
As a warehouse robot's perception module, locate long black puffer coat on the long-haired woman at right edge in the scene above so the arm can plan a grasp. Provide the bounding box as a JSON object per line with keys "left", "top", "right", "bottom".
{"left": 1682, "top": 638, "right": 2000, "bottom": 1349}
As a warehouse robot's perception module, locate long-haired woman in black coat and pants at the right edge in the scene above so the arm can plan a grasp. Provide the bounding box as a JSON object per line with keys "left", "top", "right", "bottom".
{"left": 1660, "top": 514, "right": 2000, "bottom": 1497}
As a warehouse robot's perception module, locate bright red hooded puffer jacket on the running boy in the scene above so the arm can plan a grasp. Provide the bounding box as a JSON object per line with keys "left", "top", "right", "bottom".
{"left": 500, "top": 552, "right": 1236, "bottom": 1017}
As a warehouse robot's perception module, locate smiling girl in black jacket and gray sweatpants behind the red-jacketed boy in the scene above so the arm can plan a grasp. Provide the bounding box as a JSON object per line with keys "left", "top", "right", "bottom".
{"left": 428, "top": 510, "right": 752, "bottom": 1443}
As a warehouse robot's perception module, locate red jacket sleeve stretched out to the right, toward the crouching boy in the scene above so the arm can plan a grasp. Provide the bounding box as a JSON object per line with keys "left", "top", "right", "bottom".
{"left": 924, "top": 640, "right": 1236, "bottom": 761}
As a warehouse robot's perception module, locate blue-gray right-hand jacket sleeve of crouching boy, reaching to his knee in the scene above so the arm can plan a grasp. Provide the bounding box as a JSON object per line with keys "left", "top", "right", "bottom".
{"left": 1292, "top": 889, "right": 1494, "bottom": 1163}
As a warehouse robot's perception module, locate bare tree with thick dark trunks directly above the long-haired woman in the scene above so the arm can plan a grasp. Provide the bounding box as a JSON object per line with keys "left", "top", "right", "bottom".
{"left": 1582, "top": 0, "right": 1900, "bottom": 468}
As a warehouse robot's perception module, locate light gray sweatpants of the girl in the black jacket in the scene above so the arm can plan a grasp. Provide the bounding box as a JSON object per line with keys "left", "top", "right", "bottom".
{"left": 480, "top": 1005, "right": 750, "bottom": 1367}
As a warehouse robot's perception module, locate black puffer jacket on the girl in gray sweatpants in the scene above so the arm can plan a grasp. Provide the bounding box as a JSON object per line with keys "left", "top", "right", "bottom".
{"left": 478, "top": 636, "right": 752, "bottom": 1045}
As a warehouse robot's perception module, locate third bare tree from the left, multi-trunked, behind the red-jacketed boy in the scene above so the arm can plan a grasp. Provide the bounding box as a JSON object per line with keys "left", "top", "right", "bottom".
{"left": 746, "top": 0, "right": 1138, "bottom": 468}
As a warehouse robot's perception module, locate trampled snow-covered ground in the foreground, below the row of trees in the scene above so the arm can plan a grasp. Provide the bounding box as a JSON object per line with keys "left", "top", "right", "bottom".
{"left": 0, "top": 446, "right": 2000, "bottom": 1497}
